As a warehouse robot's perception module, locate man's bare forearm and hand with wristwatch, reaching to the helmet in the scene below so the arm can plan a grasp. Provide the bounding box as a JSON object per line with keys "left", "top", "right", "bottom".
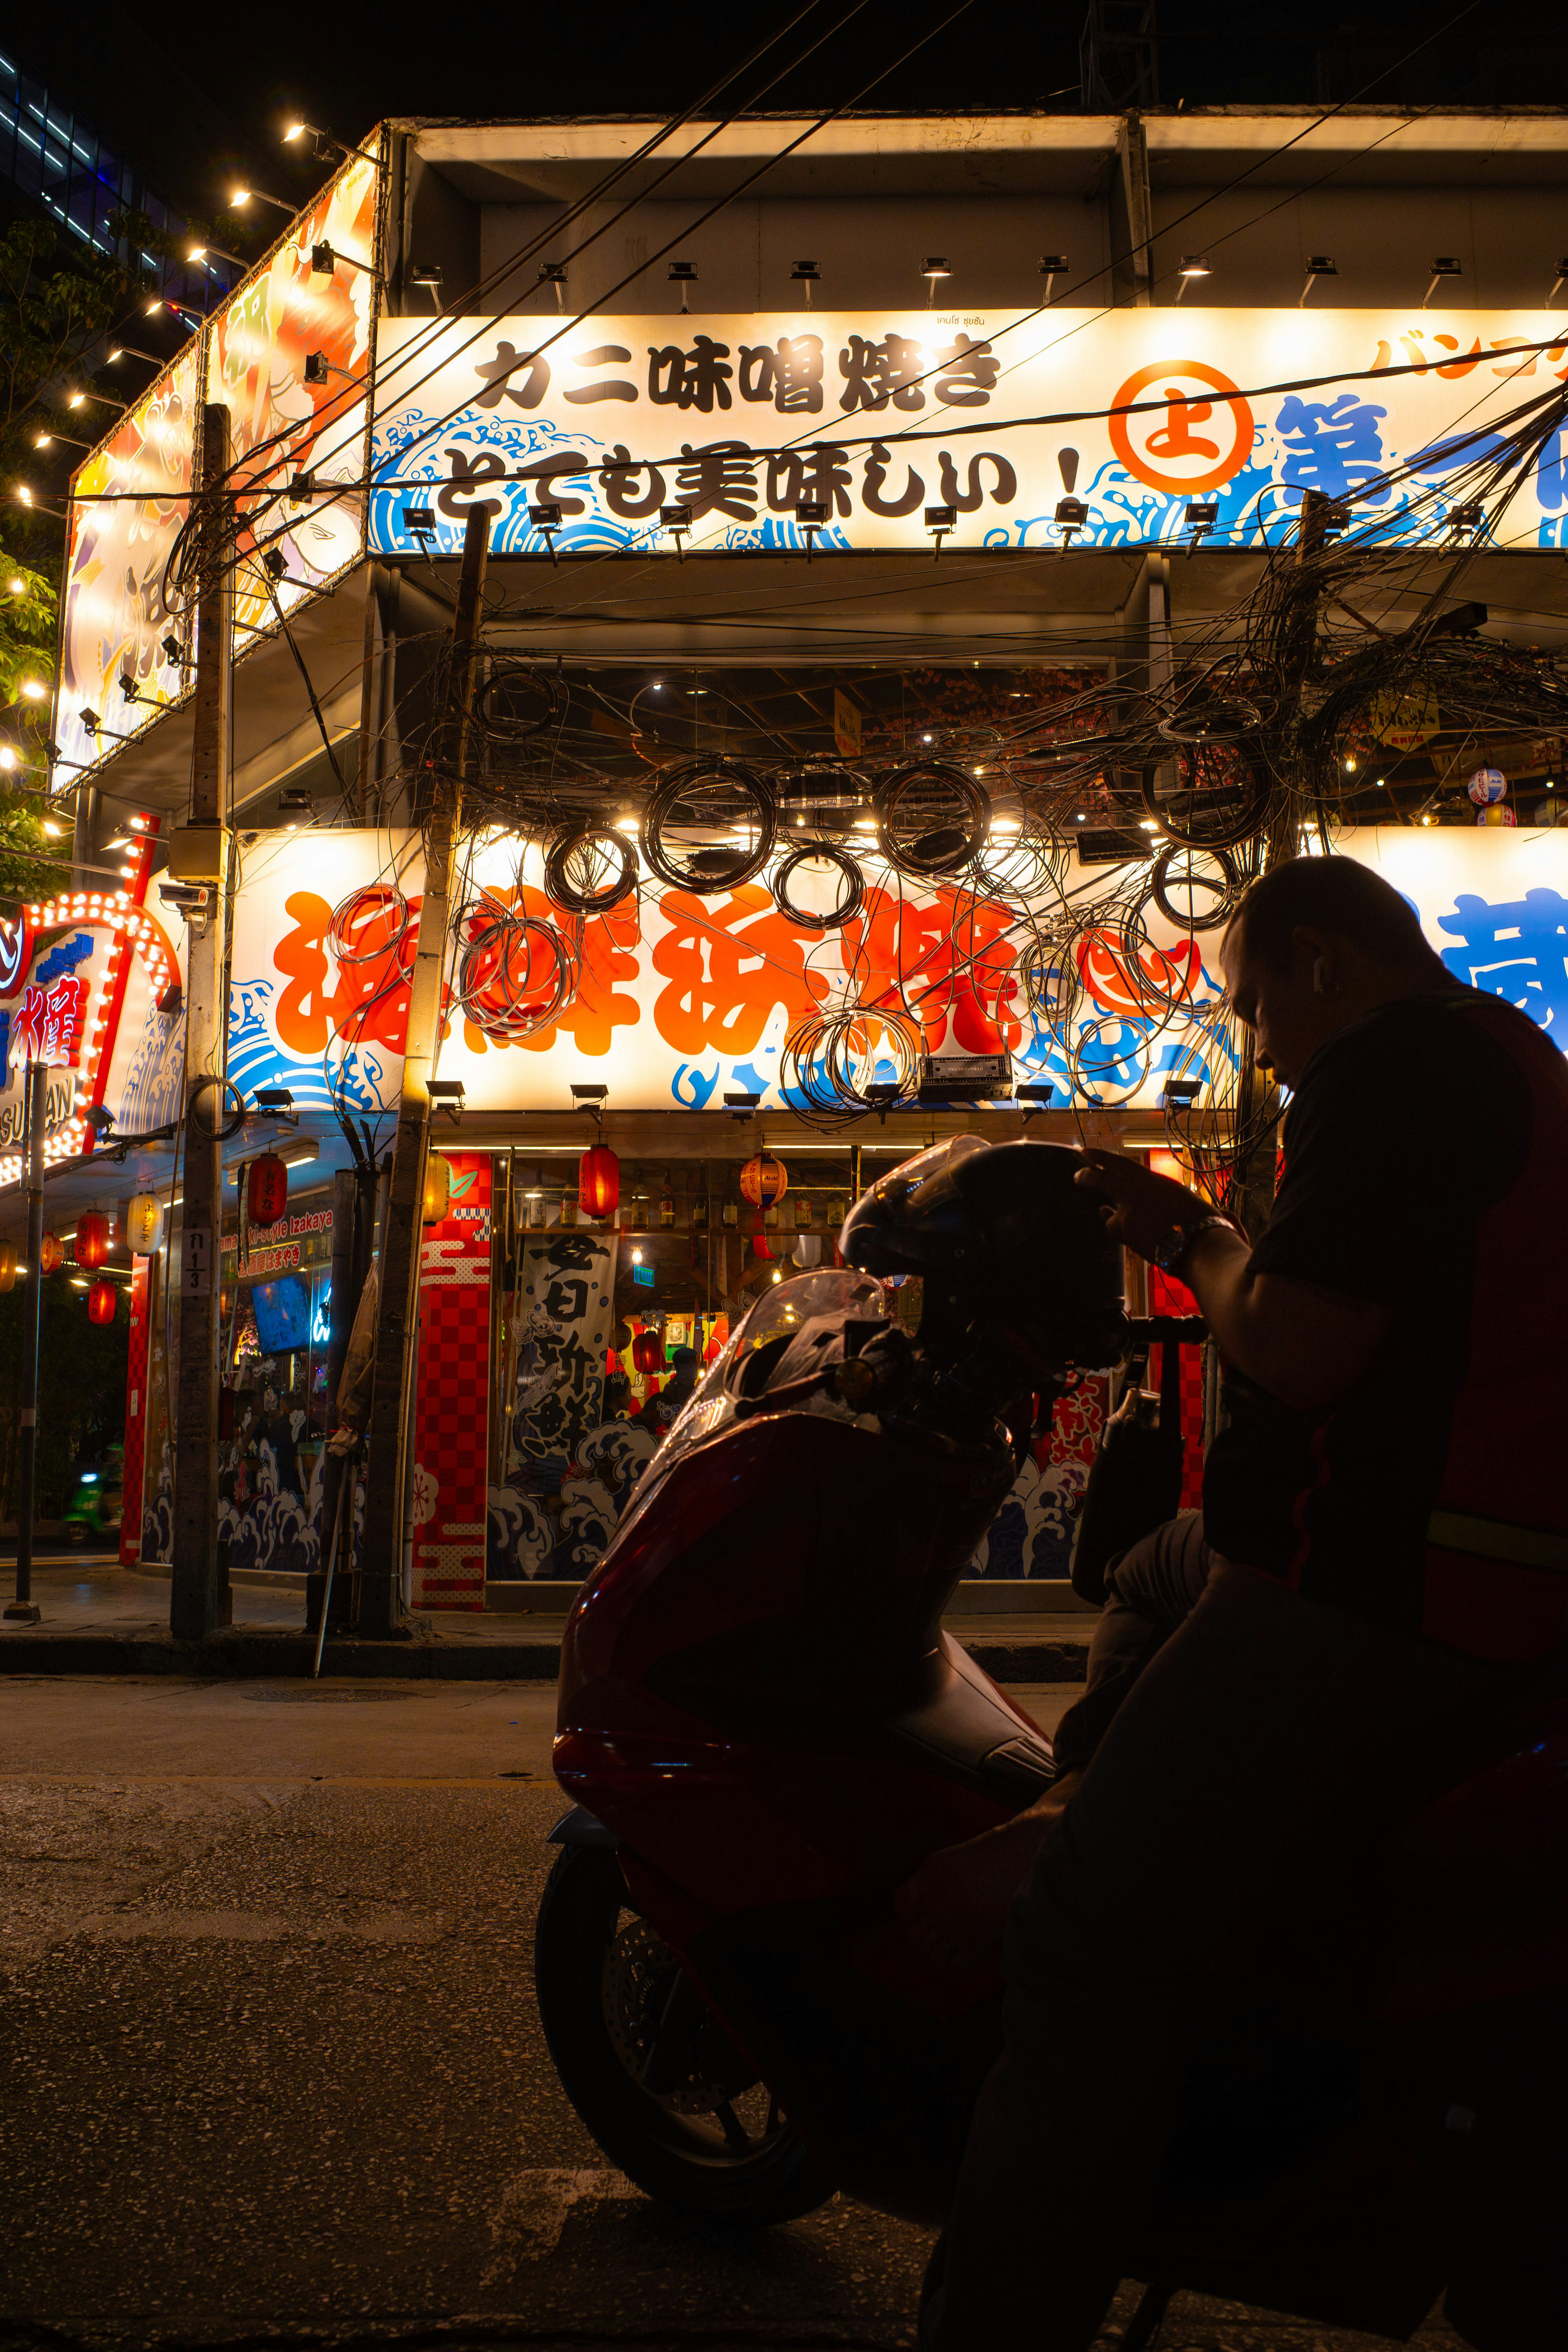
{"left": 1077, "top": 1150, "right": 1389, "bottom": 1414}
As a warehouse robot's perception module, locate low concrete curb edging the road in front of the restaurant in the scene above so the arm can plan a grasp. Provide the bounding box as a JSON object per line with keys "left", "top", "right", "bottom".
{"left": 0, "top": 1628, "right": 1089, "bottom": 1682}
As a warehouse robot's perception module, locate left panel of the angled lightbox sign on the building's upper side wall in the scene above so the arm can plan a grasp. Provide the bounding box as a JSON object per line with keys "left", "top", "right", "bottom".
{"left": 54, "top": 343, "right": 200, "bottom": 776}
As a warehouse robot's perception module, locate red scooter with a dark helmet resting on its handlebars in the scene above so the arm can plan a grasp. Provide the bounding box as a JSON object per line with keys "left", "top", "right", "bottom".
{"left": 536, "top": 1136, "right": 1568, "bottom": 2352}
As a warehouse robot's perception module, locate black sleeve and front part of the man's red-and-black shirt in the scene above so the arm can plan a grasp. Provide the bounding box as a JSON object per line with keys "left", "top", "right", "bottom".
{"left": 1204, "top": 988, "right": 1540, "bottom": 1630}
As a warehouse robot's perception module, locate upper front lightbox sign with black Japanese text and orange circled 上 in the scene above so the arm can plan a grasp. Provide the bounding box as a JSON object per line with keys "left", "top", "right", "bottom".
{"left": 369, "top": 306, "right": 1568, "bottom": 555}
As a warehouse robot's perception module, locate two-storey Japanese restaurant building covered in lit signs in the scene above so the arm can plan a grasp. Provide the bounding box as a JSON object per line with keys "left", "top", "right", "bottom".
{"left": 0, "top": 108, "right": 1568, "bottom": 1606}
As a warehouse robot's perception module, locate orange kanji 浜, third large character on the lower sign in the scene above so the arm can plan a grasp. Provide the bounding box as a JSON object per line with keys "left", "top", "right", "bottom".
{"left": 653, "top": 882, "right": 828, "bottom": 1054}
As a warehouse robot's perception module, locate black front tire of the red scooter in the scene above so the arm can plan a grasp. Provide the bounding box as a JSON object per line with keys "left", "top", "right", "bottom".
{"left": 534, "top": 1846, "right": 832, "bottom": 2230}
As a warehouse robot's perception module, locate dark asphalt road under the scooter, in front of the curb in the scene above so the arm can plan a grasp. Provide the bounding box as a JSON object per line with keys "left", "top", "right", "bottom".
{"left": 0, "top": 1677, "right": 1460, "bottom": 2352}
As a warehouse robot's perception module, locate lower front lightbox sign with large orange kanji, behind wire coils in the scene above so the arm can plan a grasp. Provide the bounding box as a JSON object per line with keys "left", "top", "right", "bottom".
{"left": 228, "top": 826, "right": 1568, "bottom": 1117}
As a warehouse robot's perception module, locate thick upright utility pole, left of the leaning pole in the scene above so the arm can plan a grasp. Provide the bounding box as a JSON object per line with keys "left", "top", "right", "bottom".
{"left": 169, "top": 402, "right": 235, "bottom": 1642}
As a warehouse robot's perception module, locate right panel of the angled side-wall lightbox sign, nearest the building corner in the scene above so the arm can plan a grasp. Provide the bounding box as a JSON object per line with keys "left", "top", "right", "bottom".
{"left": 207, "top": 158, "right": 381, "bottom": 652}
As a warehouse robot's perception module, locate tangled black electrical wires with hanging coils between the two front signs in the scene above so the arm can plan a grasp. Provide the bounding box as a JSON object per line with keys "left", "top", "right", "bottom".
{"left": 297, "top": 362, "right": 1568, "bottom": 1171}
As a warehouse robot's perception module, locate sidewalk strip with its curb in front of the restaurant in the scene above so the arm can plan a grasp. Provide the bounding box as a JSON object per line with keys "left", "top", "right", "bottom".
{"left": 0, "top": 1559, "right": 1093, "bottom": 1682}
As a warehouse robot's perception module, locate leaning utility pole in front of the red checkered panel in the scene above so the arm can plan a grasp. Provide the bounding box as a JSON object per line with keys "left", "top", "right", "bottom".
{"left": 357, "top": 508, "right": 489, "bottom": 1642}
